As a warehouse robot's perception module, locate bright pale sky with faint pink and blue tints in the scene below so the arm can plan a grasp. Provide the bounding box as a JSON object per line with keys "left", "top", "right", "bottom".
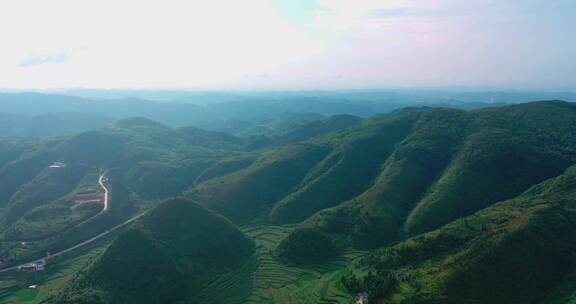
{"left": 0, "top": 0, "right": 576, "bottom": 90}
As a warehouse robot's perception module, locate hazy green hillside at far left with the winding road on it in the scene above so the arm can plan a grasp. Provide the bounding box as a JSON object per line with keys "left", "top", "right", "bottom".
{"left": 0, "top": 118, "right": 245, "bottom": 261}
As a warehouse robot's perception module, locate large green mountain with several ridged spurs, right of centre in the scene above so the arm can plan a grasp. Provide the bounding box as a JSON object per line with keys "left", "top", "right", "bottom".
{"left": 188, "top": 101, "right": 576, "bottom": 248}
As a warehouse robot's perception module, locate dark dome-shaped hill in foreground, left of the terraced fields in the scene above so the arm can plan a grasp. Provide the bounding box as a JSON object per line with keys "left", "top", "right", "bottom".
{"left": 42, "top": 199, "right": 254, "bottom": 304}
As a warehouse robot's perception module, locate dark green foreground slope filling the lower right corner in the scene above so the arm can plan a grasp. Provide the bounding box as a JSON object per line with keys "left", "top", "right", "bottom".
{"left": 348, "top": 167, "right": 576, "bottom": 303}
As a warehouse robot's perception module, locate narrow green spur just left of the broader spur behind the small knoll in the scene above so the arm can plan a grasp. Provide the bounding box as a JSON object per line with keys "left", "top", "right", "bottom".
{"left": 271, "top": 112, "right": 412, "bottom": 223}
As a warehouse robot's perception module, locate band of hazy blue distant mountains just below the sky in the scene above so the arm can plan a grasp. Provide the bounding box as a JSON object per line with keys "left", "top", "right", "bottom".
{"left": 0, "top": 90, "right": 576, "bottom": 137}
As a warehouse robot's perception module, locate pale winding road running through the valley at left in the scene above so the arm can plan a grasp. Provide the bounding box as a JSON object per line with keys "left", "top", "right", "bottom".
{"left": 0, "top": 171, "right": 146, "bottom": 273}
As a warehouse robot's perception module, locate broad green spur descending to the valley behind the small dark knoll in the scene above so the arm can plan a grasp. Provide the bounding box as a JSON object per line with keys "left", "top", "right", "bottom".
{"left": 306, "top": 110, "right": 464, "bottom": 247}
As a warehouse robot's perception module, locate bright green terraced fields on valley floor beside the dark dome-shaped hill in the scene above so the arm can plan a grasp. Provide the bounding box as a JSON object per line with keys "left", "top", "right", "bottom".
{"left": 194, "top": 223, "right": 363, "bottom": 304}
